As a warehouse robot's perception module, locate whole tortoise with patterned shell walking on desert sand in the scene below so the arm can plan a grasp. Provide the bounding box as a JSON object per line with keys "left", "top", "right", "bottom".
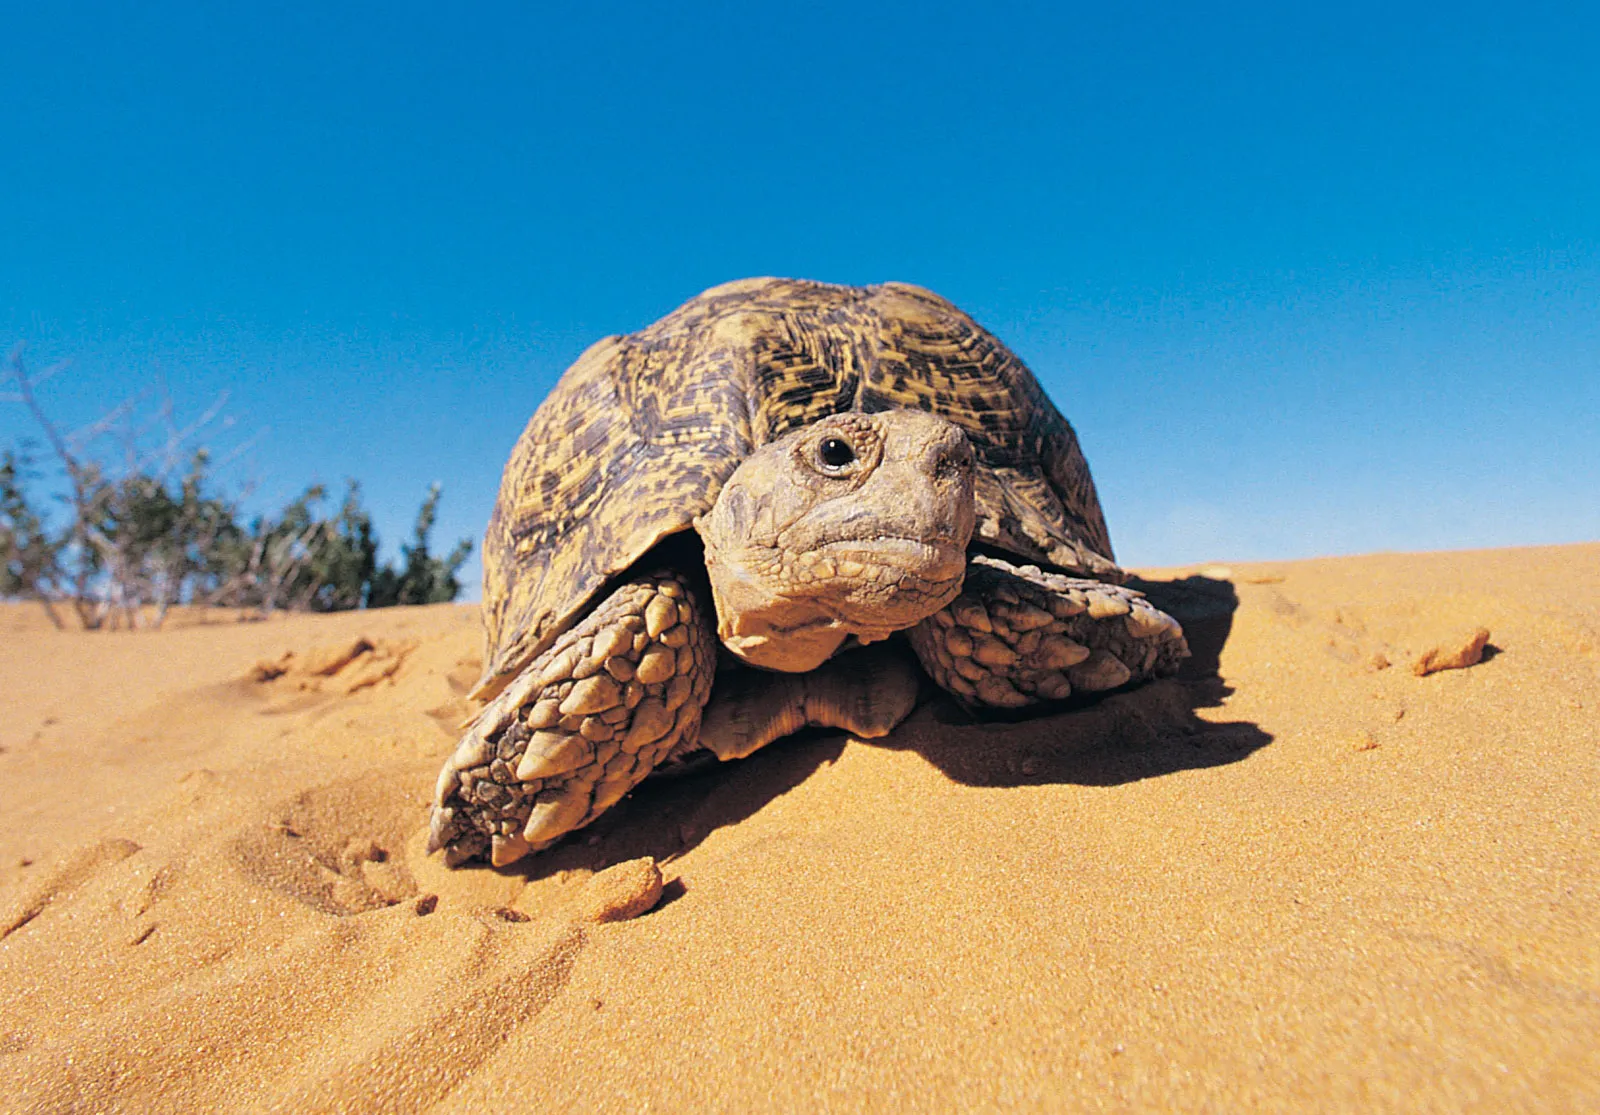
{"left": 429, "top": 278, "right": 1189, "bottom": 865}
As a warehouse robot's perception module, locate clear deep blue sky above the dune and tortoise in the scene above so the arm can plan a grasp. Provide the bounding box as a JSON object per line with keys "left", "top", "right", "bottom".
{"left": 0, "top": 3, "right": 1600, "bottom": 595}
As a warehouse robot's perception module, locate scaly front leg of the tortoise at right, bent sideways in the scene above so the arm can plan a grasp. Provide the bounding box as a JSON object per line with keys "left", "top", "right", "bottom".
{"left": 907, "top": 557, "right": 1189, "bottom": 709}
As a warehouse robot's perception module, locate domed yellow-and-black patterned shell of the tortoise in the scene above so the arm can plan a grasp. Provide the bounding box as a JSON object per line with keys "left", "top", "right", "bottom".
{"left": 477, "top": 278, "right": 1122, "bottom": 697}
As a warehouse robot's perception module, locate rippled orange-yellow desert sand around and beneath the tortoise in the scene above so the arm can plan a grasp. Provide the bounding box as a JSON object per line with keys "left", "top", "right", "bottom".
{"left": 0, "top": 544, "right": 1600, "bottom": 1112}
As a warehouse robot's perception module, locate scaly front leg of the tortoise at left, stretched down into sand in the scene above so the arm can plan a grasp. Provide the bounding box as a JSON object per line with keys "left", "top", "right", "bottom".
{"left": 429, "top": 571, "right": 717, "bottom": 867}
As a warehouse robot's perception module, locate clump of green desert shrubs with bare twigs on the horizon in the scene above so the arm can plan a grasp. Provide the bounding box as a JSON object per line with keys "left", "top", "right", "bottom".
{"left": 0, "top": 352, "right": 472, "bottom": 629}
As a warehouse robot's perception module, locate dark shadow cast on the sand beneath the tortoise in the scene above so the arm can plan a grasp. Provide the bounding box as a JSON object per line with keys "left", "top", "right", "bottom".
{"left": 502, "top": 577, "right": 1272, "bottom": 876}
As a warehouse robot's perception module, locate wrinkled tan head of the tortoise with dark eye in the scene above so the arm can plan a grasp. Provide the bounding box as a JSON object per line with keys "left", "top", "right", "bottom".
{"left": 694, "top": 411, "right": 974, "bottom": 672}
